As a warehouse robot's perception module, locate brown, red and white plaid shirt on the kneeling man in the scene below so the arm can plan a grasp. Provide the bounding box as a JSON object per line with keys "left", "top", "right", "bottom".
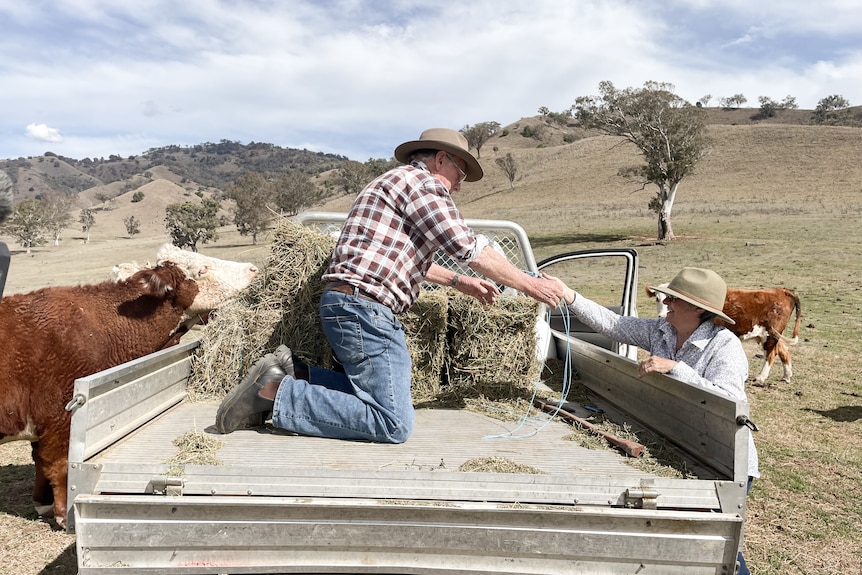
{"left": 323, "top": 162, "right": 481, "bottom": 313}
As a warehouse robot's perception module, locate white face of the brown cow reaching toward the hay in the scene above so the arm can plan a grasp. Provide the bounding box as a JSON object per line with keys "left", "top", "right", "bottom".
{"left": 158, "top": 244, "right": 258, "bottom": 316}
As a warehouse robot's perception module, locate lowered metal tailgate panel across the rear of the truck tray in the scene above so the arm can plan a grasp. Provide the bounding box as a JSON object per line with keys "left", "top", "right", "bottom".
{"left": 75, "top": 496, "right": 742, "bottom": 575}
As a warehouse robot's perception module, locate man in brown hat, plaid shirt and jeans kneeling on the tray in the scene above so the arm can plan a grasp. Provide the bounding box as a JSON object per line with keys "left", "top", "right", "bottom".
{"left": 216, "top": 128, "right": 563, "bottom": 443}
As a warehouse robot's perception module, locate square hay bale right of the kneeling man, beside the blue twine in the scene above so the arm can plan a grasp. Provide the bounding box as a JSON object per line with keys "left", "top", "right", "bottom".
{"left": 443, "top": 293, "right": 541, "bottom": 401}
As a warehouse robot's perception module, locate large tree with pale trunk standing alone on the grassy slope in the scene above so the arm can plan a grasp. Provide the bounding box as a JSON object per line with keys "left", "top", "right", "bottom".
{"left": 573, "top": 81, "right": 710, "bottom": 240}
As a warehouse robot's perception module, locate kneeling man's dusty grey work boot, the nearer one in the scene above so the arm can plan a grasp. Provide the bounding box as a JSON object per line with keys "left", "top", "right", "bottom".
{"left": 216, "top": 353, "right": 285, "bottom": 433}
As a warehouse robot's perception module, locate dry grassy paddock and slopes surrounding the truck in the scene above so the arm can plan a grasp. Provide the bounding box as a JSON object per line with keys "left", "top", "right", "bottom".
{"left": 0, "top": 121, "right": 862, "bottom": 575}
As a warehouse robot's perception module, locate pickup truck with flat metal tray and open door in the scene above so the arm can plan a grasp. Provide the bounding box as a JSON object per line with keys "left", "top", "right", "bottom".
{"left": 68, "top": 213, "right": 750, "bottom": 575}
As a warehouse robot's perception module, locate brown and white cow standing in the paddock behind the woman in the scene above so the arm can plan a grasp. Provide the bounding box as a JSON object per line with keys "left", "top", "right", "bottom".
{"left": 646, "top": 284, "right": 802, "bottom": 385}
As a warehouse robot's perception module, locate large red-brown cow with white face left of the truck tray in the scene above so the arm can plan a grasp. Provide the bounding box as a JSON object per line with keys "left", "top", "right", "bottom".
{"left": 0, "top": 244, "right": 257, "bottom": 527}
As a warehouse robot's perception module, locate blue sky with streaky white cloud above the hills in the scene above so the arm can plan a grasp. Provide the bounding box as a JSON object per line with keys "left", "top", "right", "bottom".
{"left": 0, "top": 0, "right": 862, "bottom": 162}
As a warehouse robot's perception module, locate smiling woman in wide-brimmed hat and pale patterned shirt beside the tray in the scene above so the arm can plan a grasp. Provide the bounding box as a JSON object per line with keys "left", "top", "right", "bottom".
{"left": 545, "top": 268, "right": 760, "bottom": 575}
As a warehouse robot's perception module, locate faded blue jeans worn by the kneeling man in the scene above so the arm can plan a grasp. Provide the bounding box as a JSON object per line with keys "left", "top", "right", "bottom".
{"left": 272, "top": 291, "right": 414, "bottom": 443}
